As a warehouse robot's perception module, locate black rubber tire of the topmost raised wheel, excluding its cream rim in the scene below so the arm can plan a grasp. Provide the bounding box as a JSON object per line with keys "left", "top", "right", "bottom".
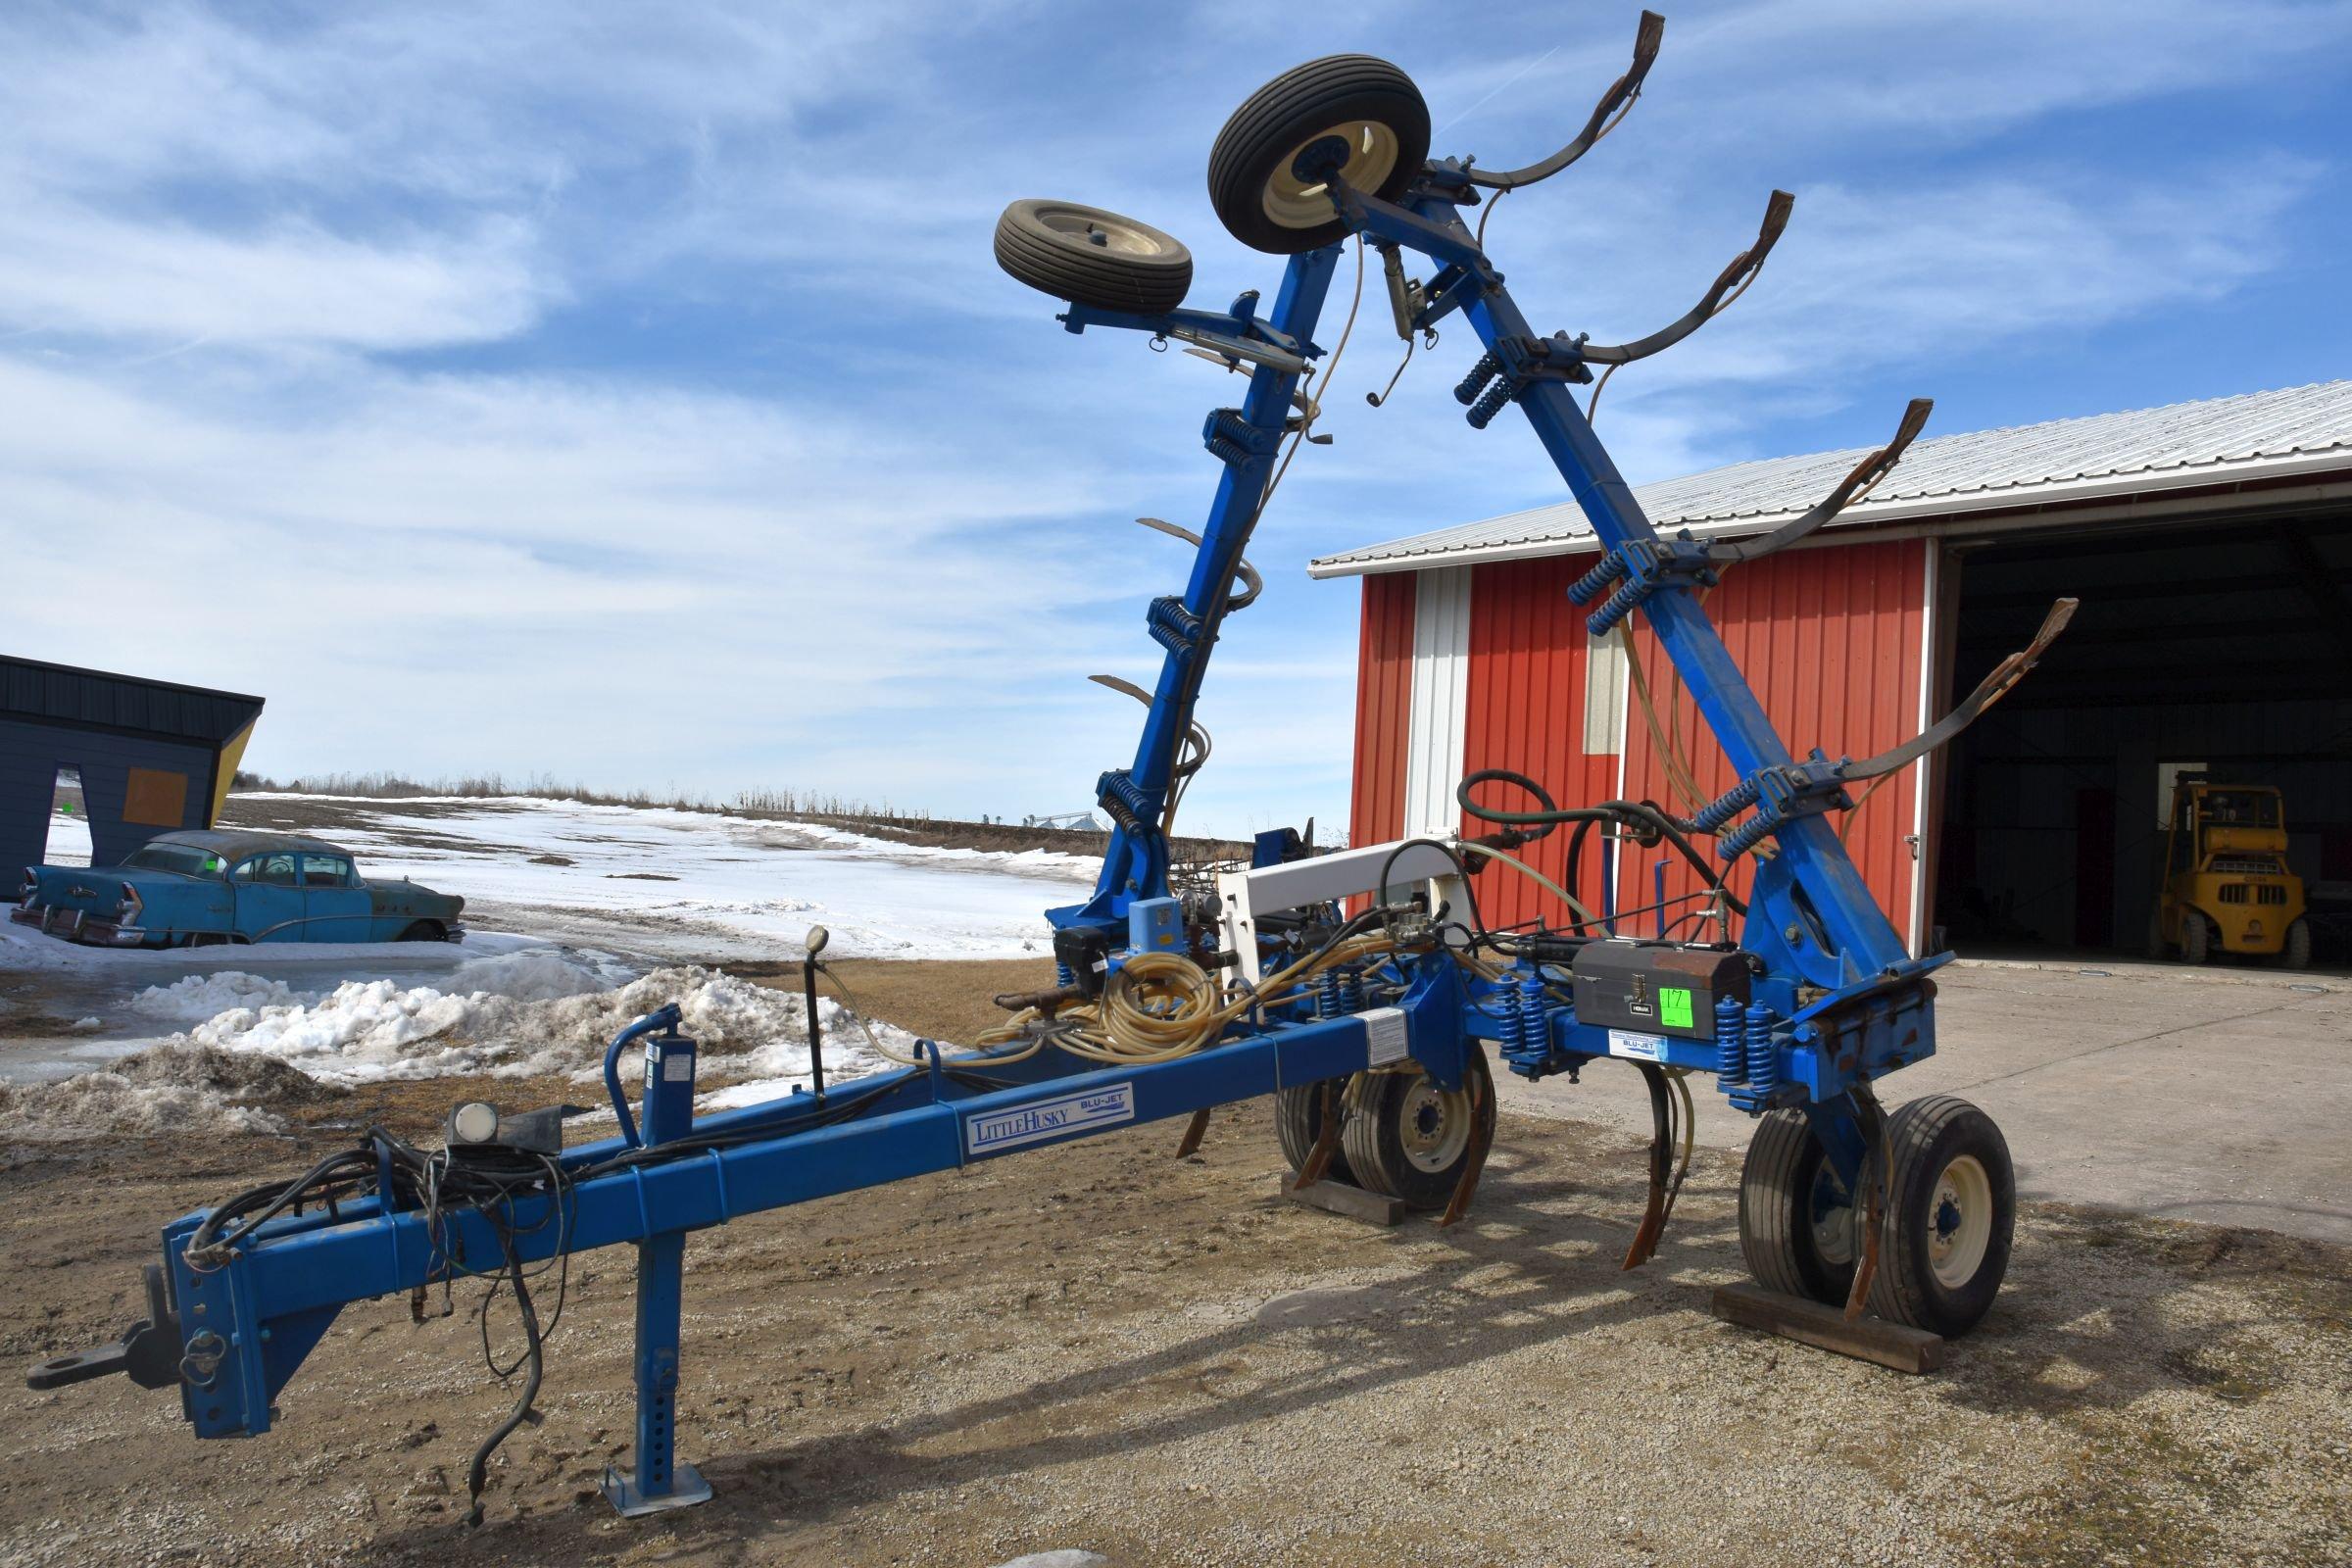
{"left": 1209, "top": 54, "right": 1430, "bottom": 256}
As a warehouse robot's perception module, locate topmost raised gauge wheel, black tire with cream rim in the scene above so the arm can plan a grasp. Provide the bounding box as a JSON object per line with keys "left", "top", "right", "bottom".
{"left": 1209, "top": 54, "right": 1430, "bottom": 256}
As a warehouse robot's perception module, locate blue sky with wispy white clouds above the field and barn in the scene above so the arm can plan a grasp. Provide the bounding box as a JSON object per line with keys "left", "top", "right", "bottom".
{"left": 0, "top": 0, "right": 2352, "bottom": 830}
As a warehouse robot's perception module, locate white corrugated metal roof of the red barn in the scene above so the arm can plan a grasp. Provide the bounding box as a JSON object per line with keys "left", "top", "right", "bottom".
{"left": 1307, "top": 381, "right": 2352, "bottom": 578}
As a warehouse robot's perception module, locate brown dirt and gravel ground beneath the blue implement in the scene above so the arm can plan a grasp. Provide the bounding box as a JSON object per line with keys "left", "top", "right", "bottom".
{"left": 0, "top": 964, "right": 2352, "bottom": 1568}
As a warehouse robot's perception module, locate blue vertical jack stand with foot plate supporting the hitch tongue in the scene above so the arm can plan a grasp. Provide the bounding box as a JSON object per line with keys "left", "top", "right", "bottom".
{"left": 605, "top": 1020, "right": 710, "bottom": 1519}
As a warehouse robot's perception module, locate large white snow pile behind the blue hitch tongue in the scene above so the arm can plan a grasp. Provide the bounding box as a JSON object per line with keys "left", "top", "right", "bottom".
{"left": 148, "top": 953, "right": 912, "bottom": 1086}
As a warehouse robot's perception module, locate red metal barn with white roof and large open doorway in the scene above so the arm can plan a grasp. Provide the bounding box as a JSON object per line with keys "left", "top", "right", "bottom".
{"left": 1310, "top": 381, "right": 2352, "bottom": 956}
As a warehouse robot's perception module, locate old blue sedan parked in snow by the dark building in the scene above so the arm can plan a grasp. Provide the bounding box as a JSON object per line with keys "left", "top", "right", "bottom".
{"left": 10, "top": 830, "right": 466, "bottom": 948}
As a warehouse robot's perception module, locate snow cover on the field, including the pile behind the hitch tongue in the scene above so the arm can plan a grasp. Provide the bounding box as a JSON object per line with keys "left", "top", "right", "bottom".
{"left": 0, "top": 795, "right": 1094, "bottom": 1104}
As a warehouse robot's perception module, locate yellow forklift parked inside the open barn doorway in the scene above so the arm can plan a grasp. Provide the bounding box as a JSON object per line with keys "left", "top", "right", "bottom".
{"left": 2147, "top": 773, "right": 2312, "bottom": 968}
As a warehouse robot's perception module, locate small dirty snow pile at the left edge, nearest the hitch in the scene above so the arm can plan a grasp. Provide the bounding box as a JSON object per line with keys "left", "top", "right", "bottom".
{"left": 0, "top": 1044, "right": 329, "bottom": 1143}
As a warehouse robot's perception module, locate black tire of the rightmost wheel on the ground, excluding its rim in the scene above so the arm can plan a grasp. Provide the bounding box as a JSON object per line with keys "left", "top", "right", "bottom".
{"left": 1870, "top": 1096, "right": 2018, "bottom": 1338}
